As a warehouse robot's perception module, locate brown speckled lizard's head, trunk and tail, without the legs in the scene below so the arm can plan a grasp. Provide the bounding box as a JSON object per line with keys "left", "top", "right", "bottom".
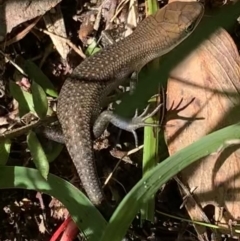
{"left": 57, "top": 2, "right": 204, "bottom": 206}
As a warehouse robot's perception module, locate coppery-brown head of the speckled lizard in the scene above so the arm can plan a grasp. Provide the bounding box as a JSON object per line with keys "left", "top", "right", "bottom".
{"left": 146, "top": 2, "right": 204, "bottom": 55}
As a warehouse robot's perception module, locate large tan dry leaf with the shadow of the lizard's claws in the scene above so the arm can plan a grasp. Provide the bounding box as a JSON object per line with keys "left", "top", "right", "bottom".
{"left": 166, "top": 29, "right": 240, "bottom": 238}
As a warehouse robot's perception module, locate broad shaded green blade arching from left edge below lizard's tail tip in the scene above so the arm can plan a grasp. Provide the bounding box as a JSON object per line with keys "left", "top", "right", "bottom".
{"left": 0, "top": 166, "right": 107, "bottom": 241}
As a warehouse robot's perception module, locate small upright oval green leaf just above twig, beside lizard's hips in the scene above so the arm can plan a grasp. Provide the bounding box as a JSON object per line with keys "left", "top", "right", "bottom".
{"left": 31, "top": 81, "right": 48, "bottom": 119}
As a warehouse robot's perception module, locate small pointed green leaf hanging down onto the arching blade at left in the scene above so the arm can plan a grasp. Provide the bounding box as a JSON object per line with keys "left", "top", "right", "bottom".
{"left": 27, "top": 131, "right": 49, "bottom": 180}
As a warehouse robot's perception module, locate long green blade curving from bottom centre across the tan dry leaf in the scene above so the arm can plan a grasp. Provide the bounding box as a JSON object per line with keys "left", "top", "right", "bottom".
{"left": 101, "top": 123, "right": 240, "bottom": 241}
